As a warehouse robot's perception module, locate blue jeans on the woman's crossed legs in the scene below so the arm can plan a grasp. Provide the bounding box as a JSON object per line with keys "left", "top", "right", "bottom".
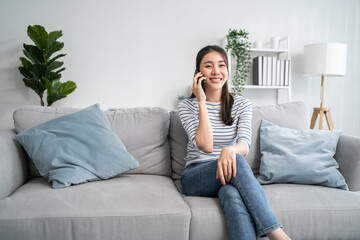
{"left": 181, "top": 154, "right": 282, "bottom": 240}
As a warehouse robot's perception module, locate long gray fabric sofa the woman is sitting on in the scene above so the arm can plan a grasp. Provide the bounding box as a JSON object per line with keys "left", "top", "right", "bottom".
{"left": 0, "top": 102, "right": 360, "bottom": 240}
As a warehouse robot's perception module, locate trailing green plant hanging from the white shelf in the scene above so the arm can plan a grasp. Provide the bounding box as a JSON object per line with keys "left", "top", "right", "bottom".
{"left": 225, "top": 29, "right": 251, "bottom": 95}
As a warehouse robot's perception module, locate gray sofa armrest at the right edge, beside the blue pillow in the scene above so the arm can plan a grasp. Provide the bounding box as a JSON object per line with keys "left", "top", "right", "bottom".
{"left": 334, "top": 135, "right": 360, "bottom": 191}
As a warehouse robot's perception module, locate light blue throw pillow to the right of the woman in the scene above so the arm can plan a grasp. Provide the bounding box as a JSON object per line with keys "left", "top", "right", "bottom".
{"left": 257, "top": 120, "right": 349, "bottom": 190}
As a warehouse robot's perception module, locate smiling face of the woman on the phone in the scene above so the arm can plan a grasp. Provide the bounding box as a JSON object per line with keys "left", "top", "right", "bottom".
{"left": 200, "top": 51, "right": 228, "bottom": 90}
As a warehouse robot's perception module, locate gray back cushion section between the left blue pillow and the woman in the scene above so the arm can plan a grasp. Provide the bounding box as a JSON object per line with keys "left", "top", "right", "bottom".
{"left": 106, "top": 107, "right": 171, "bottom": 176}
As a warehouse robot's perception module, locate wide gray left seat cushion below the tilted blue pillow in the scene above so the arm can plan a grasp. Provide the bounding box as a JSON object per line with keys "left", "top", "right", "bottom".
{"left": 0, "top": 174, "right": 190, "bottom": 240}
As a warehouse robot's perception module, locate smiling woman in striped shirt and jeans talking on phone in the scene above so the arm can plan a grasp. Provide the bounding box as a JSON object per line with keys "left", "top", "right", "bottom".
{"left": 178, "top": 46, "right": 289, "bottom": 240}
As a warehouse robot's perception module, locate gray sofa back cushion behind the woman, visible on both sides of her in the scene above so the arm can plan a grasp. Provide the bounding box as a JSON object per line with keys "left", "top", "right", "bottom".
{"left": 169, "top": 102, "right": 310, "bottom": 180}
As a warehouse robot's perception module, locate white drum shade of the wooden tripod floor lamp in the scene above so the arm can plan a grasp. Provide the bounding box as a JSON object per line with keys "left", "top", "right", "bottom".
{"left": 304, "top": 43, "right": 347, "bottom": 77}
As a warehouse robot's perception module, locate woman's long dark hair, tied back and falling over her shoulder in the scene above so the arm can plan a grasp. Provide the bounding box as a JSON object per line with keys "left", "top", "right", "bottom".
{"left": 190, "top": 45, "right": 234, "bottom": 126}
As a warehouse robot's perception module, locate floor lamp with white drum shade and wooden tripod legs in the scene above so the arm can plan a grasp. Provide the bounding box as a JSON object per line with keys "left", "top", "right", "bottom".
{"left": 304, "top": 43, "right": 347, "bottom": 130}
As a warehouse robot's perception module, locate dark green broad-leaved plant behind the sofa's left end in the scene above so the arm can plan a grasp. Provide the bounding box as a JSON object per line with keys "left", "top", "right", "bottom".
{"left": 19, "top": 25, "right": 76, "bottom": 106}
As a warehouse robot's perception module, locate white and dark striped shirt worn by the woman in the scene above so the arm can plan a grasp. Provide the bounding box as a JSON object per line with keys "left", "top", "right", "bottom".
{"left": 177, "top": 95, "right": 252, "bottom": 167}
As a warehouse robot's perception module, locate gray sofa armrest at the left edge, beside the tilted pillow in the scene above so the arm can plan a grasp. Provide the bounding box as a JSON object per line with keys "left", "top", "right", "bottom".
{"left": 0, "top": 130, "right": 28, "bottom": 199}
